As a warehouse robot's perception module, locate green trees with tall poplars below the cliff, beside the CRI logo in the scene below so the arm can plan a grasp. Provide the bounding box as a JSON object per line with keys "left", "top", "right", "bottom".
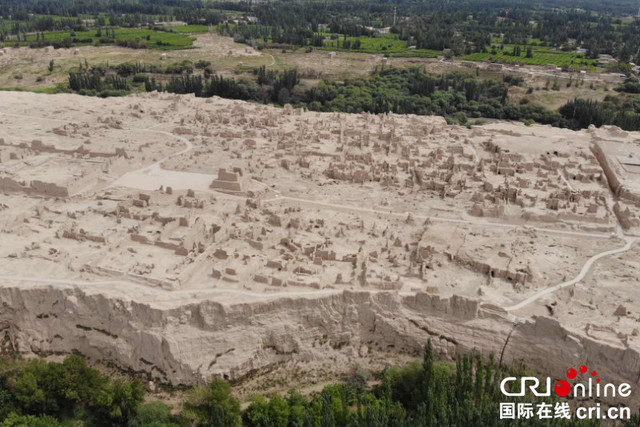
{"left": 231, "top": 342, "right": 588, "bottom": 427}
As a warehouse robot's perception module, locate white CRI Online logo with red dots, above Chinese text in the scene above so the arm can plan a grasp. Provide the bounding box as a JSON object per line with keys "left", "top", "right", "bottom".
{"left": 500, "top": 365, "right": 631, "bottom": 397}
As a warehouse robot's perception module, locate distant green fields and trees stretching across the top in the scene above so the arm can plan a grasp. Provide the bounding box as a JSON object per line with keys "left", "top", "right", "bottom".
{"left": 0, "top": 0, "right": 640, "bottom": 69}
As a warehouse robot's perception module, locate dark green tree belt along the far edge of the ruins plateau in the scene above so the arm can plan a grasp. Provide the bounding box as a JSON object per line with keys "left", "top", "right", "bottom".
{"left": 56, "top": 60, "right": 640, "bottom": 130}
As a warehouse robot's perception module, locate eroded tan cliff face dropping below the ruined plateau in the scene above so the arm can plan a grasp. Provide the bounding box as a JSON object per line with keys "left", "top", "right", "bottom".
{"left": 0, "top": 287, "right": 640, "bottom": 406}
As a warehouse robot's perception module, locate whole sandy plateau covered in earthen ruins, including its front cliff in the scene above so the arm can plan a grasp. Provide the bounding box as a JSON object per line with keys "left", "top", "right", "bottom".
{"left": 0, "top": 92, "right": 640, "bottom": 404}
